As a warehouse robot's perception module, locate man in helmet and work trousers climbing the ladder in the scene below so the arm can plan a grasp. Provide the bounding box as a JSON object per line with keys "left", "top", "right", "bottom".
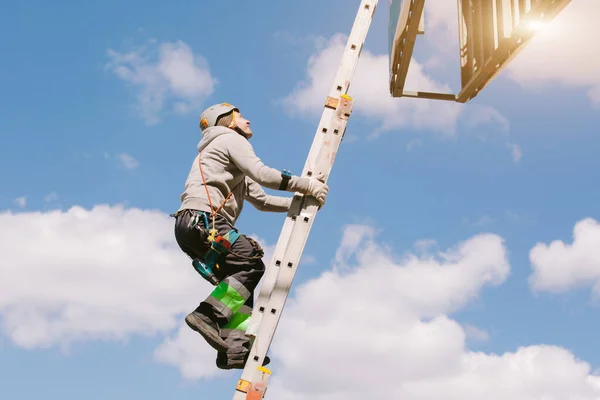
{"left": 173, "top": 103, "right": 328, "bottom": 369}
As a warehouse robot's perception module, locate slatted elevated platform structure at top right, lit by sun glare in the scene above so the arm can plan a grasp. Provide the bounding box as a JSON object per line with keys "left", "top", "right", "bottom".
{"left": 388, "top": 0, "right": 572, "bottom": 103}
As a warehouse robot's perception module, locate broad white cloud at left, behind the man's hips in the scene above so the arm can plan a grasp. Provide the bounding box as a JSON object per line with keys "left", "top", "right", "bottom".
{"left": 0, "top": 206, "right": 203, "bottom": 349}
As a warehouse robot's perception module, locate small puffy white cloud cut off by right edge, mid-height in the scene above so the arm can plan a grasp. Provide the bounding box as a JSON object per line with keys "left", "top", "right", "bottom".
{"left": 529, "top": 218, "right": 600, "bottom": 296}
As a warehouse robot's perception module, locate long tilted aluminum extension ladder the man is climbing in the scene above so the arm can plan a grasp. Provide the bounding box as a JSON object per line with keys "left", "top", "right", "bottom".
{"left": 233, "top": 0, "right": 378, "bottom": 400}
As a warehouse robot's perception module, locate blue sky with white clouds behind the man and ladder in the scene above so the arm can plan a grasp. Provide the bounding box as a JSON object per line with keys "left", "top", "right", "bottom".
{"left": 0, "top": 0, "right": 600, "bottom": 400}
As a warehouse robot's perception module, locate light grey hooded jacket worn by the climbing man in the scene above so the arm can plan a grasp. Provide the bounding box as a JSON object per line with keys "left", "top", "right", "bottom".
{"left": 179, "top": 126, "right": 309, "bottom": 225}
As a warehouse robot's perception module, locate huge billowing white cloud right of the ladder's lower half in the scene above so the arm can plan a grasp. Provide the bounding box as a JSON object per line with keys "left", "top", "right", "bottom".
{"left": 258, "top": 225, "right": 600, "bottom": 400}
